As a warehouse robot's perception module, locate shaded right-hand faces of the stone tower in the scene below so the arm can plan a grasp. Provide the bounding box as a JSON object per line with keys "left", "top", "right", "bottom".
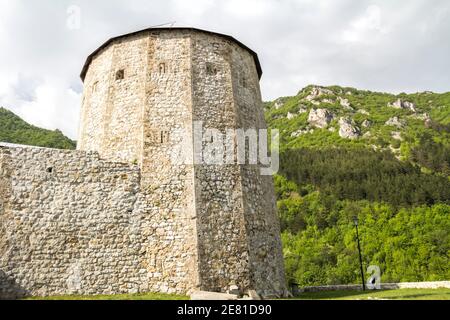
{"left": 189, "top": 34, "right": 285, "bottom": 296}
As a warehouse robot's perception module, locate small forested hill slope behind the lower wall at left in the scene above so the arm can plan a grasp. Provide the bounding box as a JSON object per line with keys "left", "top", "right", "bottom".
{"left": 0, "top": 107, "right": 76, "bottom": 149}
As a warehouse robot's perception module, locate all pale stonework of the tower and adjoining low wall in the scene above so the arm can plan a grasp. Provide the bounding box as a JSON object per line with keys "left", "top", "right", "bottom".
{"left": 0, "top": 29, "right": 285, "bottom": 296}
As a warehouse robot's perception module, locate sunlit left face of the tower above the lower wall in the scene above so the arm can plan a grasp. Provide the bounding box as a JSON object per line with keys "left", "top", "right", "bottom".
{"left": 78, "top": 36, "right": 147, "bottom": 163}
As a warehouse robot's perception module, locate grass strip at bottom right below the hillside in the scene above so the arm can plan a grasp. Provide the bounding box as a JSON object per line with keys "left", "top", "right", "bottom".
{"left": 295, "top": 288, "right": 450, "bottom": 300}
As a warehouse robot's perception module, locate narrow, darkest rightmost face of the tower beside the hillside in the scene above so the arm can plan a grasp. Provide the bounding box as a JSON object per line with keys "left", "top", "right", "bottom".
{"left": 231, "top": 48, "right": 286, "bottom": 296}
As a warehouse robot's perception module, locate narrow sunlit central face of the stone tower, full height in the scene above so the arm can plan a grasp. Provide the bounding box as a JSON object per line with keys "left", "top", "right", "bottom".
{"left": 141, "top": 31, "right": 198, "bottom": 293}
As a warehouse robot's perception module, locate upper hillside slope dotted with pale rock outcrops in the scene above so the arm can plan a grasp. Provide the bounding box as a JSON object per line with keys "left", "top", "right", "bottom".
{"left": 266, "top": 86, "right": 450, "bottom": 157}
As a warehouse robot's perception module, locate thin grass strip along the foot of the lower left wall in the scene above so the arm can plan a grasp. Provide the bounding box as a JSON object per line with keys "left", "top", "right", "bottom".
{"left": 25, "top": 293, "right": 189, "bottom": 300}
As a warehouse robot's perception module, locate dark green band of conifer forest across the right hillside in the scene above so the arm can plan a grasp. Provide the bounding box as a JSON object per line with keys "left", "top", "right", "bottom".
{"left": 280, "top": 148, "right": 450, "bottom": 206}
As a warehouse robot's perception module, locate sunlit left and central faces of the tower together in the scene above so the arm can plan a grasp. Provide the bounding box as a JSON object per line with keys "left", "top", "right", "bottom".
{"left": 78, "top": 33, "right": 198, "bottom": 293}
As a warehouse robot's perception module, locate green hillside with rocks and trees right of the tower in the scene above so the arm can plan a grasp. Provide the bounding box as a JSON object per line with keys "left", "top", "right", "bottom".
{"left": 265, "top": 86, "right": 450, "bottom": 285}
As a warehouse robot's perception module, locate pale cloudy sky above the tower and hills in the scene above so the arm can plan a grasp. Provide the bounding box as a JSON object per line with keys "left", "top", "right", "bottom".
{"left": 0, "top": 0, "right": 450, "bottom": 138}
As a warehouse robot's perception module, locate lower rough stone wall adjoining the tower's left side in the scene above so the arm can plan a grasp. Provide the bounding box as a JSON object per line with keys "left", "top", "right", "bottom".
{"left": 0, "top": 147, "right": 156, "bottom": 298}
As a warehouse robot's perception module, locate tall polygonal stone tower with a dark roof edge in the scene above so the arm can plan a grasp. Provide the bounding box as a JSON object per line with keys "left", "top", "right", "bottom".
{"left": 78, "top": 28, "right": 286, "bottom": 296}
